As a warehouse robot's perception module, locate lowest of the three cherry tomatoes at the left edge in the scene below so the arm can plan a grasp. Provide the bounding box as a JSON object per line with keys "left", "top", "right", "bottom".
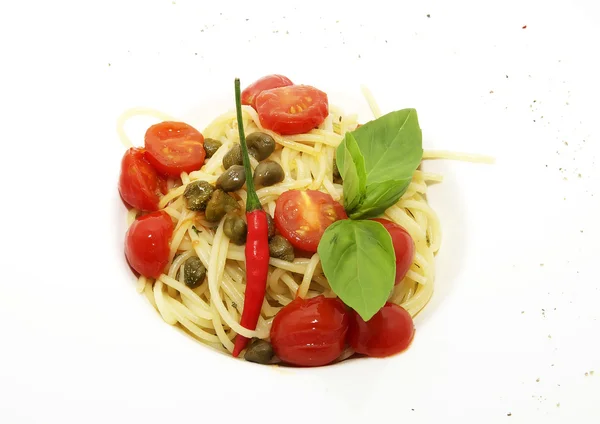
{"left": 125, "top": 211, "right": 173, "bottom": 278}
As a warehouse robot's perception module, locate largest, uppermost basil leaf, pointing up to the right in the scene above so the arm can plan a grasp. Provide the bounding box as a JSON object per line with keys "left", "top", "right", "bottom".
{"left": 336, "top": 109, "right": 423, "bottom": 219}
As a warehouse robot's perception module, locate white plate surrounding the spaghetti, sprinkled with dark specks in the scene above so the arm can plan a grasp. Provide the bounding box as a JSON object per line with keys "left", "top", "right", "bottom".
{"left": 0, "top": 0, "right": 600, "bottom": 424}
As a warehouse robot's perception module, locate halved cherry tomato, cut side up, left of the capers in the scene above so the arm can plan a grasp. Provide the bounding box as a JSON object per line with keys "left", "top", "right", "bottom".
{"left": 144, "top": 121, "right": 206, "bottom": 177}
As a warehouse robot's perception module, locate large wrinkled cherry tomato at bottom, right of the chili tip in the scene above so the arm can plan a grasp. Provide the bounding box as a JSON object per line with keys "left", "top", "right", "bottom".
{"left": 271, "top": 295, "right": 348, "bottom": 367}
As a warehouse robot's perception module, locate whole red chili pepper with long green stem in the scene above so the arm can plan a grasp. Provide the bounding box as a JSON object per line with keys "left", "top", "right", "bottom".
{"left": 233, "top": 78, "right": 269, "bottom": 357}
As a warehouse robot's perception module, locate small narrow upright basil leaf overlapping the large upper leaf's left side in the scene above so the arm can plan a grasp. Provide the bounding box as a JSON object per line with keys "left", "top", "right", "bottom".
{"left": 340, "top": 132, "right": 367, "bottom": 211}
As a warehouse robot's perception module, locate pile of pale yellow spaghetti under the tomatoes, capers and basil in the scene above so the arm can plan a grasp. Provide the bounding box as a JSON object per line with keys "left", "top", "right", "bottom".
{"left": 118, "top": 88, "right": 487, "bottom": 360}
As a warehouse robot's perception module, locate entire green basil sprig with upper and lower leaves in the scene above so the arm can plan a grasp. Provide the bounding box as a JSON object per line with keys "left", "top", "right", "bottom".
{"left": 318, "top": 109, "right": 423, "bottom": 321}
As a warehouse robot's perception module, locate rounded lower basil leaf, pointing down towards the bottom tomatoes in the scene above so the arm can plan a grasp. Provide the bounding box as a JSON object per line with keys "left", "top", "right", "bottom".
{"left": 317, "top": 219, "right": 396, "bottom": 321}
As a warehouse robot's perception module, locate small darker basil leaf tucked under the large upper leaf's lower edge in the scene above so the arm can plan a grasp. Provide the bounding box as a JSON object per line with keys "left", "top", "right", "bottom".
{"left": 348, "top": 178, "right": 411, "bottom": 219}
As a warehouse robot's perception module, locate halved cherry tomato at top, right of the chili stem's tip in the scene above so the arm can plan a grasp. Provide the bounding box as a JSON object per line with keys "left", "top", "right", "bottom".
{"left": 256, "top": 85, "right": 329, "bottom": 134}
